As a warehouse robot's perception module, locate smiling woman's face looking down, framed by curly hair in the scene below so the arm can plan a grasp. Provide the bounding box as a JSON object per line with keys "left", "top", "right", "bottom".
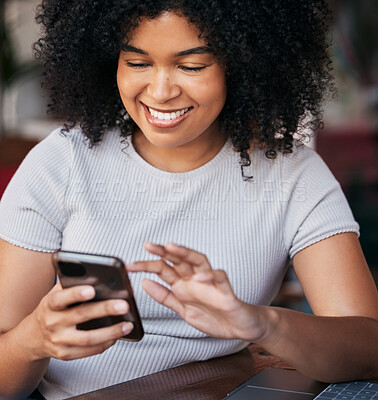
{"left": 117, "top": 12, "right": 226, "bottom": 149}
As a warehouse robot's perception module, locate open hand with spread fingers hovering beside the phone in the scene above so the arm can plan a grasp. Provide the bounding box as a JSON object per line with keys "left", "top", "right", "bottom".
{"left": 127, "top": 242, "right": 263, "bottom": 339}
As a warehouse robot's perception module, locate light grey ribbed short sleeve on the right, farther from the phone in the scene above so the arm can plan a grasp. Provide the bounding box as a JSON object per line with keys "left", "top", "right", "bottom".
{"left": 282, "top": 146, "right": 359, "bottom": 258}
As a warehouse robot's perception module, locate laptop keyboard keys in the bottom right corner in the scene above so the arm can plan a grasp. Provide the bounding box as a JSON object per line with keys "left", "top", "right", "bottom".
{"left": 314, "top": 381, "right": 378, "bottom": 400}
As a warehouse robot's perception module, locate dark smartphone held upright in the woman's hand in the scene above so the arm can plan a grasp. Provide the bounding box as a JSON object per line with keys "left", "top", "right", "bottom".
{"left": 52, "top": 251, "right": 144, "bottom": 342}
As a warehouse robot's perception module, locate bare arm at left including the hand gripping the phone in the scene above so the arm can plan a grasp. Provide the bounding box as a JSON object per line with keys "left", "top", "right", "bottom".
{"left": 0, "top": 240, "right": 132, "bottom": 399}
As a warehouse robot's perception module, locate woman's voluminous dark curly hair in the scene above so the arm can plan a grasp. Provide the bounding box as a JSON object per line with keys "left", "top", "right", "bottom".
{"left": 34, "top": 0, "right": 333, "bottom": 178}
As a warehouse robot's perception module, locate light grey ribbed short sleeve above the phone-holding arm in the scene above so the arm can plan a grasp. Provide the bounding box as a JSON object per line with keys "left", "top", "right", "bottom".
{"left": 0, "top": 129, "right": 71, "bottom": 252}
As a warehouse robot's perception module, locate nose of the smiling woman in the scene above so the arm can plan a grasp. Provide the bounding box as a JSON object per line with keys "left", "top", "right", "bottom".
{"left": 147, "top": 69, "right": 181, "bottom": 103}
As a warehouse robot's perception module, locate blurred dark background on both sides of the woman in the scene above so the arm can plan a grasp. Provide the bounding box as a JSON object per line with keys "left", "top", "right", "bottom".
{"left": 0, "top": 0, "right": 378, "bottom": 294}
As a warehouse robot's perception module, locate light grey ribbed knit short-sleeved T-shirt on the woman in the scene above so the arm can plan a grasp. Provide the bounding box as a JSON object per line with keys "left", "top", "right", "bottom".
{"left": 0, "top": 130, "right": 358, "bottom": 399}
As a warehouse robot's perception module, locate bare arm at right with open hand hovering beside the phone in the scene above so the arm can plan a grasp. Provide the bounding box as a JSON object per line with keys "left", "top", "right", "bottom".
{"left": 128, "top": 233, "right": 378, "bottom": 382}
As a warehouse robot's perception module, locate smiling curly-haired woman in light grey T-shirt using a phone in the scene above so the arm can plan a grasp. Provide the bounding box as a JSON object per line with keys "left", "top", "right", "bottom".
{"left": 0, "top": 0, "right": 378, "bottom": 399}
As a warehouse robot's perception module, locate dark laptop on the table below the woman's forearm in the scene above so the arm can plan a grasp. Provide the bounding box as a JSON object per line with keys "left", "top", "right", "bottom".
{"left": 223, "top": 368, "right": 378, "bottom": 400}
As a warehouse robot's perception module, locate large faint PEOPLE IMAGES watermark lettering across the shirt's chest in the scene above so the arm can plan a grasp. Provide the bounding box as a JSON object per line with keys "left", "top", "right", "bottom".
{"left": 68, "top": 180, "right": 307, "bottom": 205}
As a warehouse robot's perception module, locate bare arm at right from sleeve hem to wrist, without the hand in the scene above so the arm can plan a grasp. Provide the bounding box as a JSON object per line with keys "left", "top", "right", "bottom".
{"left": 267, "top": 233, "right": 378, "bottom": 381}
